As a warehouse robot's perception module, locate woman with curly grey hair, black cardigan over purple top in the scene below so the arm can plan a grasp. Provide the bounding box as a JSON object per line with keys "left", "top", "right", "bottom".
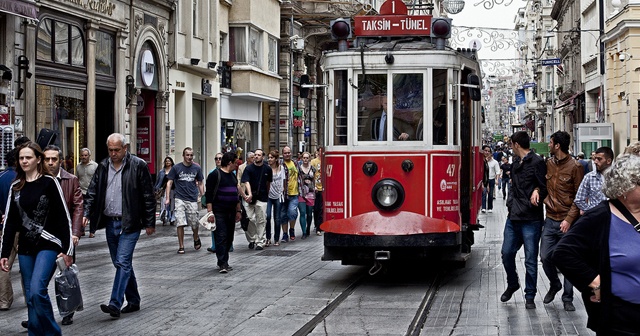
{"left": 553, "top": 154, "right": 640, "bottom": 335}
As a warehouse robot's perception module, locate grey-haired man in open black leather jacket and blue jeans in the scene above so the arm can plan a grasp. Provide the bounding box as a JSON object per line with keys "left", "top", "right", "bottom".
{"left": 83, "top": 133, "right": 156, "bottom": 318}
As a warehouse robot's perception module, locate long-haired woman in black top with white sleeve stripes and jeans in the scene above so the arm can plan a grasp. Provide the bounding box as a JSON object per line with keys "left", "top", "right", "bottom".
{"left": 0, "top": 142, "right": 73, "bottom": 335}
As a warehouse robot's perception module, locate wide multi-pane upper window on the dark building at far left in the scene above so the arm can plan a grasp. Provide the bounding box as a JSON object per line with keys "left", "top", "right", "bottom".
{"left": 36, "top": 19, "right": 84, "bottom": 66}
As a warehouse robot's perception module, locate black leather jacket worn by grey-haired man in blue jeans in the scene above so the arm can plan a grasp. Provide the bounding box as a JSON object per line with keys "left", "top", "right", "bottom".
{"left": 84, "top": 153, "right": 156, "bottom": 232}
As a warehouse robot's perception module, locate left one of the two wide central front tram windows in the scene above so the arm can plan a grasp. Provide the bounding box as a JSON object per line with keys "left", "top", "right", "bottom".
{"left": 358, "top": 74, "right": 388, "bottom": 141}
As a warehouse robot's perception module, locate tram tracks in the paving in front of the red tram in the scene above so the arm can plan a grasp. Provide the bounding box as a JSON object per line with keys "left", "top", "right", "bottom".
{"left": 293, "top": 270, "right": 448, "bottom": 336}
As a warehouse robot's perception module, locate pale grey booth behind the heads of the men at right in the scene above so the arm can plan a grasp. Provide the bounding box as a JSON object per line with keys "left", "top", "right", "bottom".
{"left": 573, "top": 123, "right": 616, "bottom": 158}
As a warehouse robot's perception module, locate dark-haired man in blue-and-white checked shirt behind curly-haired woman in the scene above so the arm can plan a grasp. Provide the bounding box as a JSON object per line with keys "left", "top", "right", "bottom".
{"left": 574, "top": 147, "right": 613, "bottom": 215}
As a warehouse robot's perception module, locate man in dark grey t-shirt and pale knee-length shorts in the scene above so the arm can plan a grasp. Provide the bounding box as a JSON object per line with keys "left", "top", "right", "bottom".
{"left": 165, "top": 147, "right": 204, "bottom": 254}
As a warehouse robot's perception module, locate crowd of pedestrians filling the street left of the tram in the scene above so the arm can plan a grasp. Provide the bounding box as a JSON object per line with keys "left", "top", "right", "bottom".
{"left": 0, "top": 133, "right": 322, "bottom": 335}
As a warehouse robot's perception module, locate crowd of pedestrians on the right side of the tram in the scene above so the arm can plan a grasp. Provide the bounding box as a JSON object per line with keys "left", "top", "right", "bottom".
{"left": 496, "top": 131, "right": 640, "bottom": 335}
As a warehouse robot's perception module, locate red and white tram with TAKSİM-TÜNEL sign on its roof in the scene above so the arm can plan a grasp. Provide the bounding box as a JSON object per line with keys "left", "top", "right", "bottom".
{"left": 321, "top": 1, "right": 484, "bottom": 265}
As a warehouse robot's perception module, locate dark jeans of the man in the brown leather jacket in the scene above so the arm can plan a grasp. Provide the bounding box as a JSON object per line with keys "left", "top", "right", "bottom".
{"left": 540, "top": 217, "right": 573, "bottom": 302}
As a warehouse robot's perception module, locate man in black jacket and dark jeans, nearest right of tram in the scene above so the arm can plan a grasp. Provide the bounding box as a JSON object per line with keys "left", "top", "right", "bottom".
{"left": 500, "top": 131, "right": 547, "bottom": 309}
